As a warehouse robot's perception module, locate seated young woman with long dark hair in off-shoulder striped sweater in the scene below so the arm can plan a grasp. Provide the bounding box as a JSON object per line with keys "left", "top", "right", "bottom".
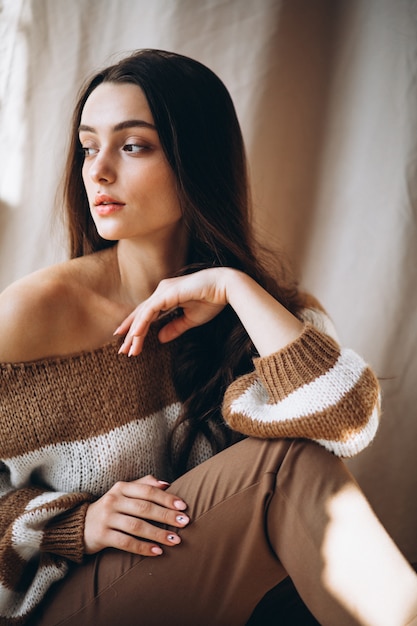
{"left": 0, "top": 50, "right": 417, "bottom": 626}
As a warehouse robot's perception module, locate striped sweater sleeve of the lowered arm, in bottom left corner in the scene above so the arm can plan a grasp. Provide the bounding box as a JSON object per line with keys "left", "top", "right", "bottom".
{"left": 0, "top": 462, "right": 92, "bottom": 624}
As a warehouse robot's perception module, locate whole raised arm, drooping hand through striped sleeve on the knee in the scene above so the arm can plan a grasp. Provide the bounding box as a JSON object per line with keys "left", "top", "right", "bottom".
{"left": 116, "top": 268, "right": 380, "bottom": 456}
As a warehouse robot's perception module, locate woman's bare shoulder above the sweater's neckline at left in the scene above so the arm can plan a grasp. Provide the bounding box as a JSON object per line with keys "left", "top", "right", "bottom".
{"left": 0, "top": 253, "right": 118, "bottom": 363}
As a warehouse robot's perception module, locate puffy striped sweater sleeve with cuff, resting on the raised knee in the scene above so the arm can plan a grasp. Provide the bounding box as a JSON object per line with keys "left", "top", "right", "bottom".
{"left": 223, "top": 322, "right": 380, "bottom": 457}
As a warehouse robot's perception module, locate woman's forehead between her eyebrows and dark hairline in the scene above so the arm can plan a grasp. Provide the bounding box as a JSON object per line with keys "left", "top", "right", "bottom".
{"left": 81, "top": 83, "right": 154, "bottom": 126}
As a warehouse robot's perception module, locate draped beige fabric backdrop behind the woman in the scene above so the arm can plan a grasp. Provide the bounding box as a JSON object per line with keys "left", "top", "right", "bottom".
{"left": 0, "top": 0, "right": 417, "bottom": 561}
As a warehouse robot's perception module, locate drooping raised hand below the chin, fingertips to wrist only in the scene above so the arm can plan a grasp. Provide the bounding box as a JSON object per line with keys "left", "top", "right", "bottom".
{"left": 115, "top": 267, "right": 234, "bottom": 356}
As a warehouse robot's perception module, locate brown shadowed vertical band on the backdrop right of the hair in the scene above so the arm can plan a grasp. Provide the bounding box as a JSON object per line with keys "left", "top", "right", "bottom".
{"left": 249, "top": 0, "right": 346, "bottom": 276}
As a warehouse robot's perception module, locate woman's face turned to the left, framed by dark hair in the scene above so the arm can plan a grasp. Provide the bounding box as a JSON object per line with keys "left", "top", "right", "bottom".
{"left": 79, "top": 83, "right": 182, "bottom": 243}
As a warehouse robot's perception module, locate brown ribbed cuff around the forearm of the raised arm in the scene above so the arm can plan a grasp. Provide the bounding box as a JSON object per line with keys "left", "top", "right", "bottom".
{"left": 254, "top": 324, "right": 340, "bottom": 402}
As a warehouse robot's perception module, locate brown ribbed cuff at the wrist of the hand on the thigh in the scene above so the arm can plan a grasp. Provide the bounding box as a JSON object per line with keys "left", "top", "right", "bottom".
{"left": 41, "top": 502, "right": 90, "bottom": 563}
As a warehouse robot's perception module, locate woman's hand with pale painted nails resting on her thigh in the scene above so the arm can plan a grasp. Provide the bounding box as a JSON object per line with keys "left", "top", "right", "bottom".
{"left": 84, "top": 476, "right": 190, "bottom": 556}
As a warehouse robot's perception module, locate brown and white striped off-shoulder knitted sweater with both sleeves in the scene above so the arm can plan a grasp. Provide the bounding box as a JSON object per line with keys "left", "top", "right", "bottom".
{"left": 0, "top": 304, "right": 379, "bottom": 624}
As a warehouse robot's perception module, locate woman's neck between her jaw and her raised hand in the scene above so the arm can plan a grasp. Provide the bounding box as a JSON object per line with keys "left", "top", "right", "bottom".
{"left": 115, "top": 228, "right": 187, "bottom": 307}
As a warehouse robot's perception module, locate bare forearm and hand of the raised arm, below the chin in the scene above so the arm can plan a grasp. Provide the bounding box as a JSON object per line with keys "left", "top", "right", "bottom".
{"left": 114, "top": 267, "right": 303, "bottom": 356}
